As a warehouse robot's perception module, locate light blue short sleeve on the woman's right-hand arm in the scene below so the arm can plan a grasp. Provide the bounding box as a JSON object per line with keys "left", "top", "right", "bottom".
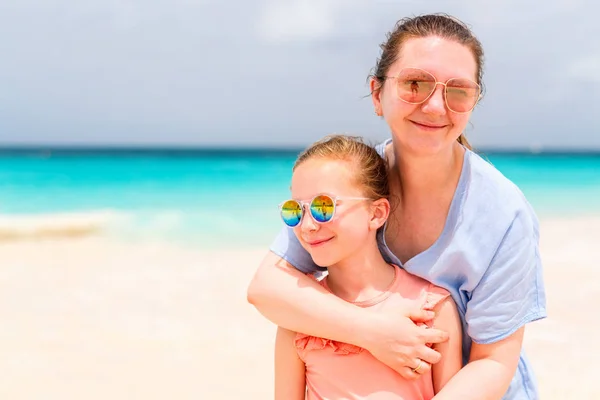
{"left": 465, "top": 210, "right": 547, "bottom": 344}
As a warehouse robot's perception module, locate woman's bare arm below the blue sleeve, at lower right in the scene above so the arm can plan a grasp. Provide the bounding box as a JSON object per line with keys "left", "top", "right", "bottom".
{"left": 434, "top": 327, "right": 525, "bottom": 400}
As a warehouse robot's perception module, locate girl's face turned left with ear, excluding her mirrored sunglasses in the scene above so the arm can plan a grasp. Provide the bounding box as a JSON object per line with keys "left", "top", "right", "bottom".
{"left": 291, "top": 158, "right": 385, "bottom": 267}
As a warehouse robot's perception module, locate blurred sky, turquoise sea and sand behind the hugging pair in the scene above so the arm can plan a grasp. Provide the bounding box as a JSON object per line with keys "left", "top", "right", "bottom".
{"left": 0, "top": 0, "right": 600, "bottom": 399}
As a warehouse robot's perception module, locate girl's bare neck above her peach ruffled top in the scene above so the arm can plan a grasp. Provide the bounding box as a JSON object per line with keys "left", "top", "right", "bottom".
{"left": 326, "top": 243, "right": 395, "bottom": 302}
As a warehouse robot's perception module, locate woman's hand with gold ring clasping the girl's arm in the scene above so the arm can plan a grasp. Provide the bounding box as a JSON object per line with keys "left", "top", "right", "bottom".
{"left": 363, "top": 309, "right": 448, "bottom": 379}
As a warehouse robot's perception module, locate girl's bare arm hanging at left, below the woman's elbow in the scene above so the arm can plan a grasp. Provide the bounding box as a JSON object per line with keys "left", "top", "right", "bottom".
{"left": 275, "top": 328, "right": 306, "bottom": 400}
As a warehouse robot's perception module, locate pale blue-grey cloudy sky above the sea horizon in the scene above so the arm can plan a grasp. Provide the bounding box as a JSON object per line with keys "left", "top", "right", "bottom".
{"left": 0, "top": 0, "right": 600, "bottom": 150}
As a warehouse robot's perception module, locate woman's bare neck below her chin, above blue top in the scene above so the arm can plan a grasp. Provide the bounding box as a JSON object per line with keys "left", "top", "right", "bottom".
{"left": 390, "top": 142, "right": 465, "bottom": 194}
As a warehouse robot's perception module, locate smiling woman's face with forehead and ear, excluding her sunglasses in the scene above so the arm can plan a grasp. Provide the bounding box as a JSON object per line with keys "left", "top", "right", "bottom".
{"left": 371, "top": 36, "right": 477, "bottom": 155}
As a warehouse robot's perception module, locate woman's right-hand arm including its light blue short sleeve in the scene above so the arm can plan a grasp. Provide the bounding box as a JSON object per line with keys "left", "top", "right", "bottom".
{"left": 435, "top": 210, "right": 546, "bottom": 400}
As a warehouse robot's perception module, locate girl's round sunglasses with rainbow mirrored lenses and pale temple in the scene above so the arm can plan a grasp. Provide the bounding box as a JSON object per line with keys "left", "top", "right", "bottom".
{"left": 279, "top": 194, "right": 370, "bottom": 227}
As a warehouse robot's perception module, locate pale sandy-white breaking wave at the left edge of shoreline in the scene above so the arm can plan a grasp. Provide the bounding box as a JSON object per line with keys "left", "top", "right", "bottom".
{"left": 0, "top": 210, "right": 128, "bottom": 241}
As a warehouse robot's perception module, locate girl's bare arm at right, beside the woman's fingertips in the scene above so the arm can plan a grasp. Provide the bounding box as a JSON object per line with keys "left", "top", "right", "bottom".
{"left": 431, "top": 297, "right": 462, "bottom": 392}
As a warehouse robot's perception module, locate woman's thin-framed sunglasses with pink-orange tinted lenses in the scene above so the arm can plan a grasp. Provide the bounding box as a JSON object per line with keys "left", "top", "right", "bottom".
{"left": 385, "top": 68, "right": 481, "bottom": 114}
